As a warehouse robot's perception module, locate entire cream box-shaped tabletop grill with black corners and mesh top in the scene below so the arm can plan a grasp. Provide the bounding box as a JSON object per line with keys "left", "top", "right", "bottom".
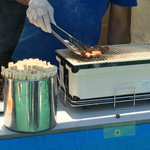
{"left": 56, "top": 44, "right": 150, "bottom": 108}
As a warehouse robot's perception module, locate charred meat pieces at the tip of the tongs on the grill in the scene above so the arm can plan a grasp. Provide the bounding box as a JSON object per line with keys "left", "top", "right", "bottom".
{"left": 80, "top": 45, "right": 109, "bottom": 58}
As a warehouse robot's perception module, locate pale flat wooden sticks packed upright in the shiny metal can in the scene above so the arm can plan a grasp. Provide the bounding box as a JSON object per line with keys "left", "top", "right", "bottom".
{"left": 1, "top": 58, "right": 57, "bottom": 80}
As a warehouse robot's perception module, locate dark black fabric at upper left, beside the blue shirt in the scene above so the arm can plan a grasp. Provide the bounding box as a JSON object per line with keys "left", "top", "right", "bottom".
{"left": 0, "top": 0, "right": 27, "bottom": 66}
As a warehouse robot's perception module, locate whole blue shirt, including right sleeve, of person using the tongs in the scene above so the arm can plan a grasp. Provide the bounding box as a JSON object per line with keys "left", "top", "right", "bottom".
{"left": 12, "top": 0, "right": 136, "bottom": 65}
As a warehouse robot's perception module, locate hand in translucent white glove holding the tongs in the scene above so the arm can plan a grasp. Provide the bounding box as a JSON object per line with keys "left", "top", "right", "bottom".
{"left": 27, "top": 0, "right": 56, "bottom": 33}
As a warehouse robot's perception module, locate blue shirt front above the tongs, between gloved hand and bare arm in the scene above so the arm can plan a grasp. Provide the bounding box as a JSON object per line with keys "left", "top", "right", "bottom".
{"left": 49, "top": 0, "right": 109, "bottom": 45}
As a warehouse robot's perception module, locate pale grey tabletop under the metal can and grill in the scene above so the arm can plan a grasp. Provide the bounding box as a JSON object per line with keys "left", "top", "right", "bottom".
{"left": 0, "top": 100, "right": 150, "bottom": 139}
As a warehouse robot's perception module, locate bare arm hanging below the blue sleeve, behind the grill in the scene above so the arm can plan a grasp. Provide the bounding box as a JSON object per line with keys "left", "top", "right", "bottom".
{"left": 108, "top": 4, "right": 130, "bottom": 45}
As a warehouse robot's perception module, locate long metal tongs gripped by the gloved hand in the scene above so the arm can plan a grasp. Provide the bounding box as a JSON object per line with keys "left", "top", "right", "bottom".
{"left": 51, "top": 23, "right": 86, "bottom": 55}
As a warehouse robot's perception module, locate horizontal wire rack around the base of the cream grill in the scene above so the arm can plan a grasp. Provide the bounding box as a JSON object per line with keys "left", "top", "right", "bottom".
{"left": 59, "top": 88, "right": 150, "bottom": 109}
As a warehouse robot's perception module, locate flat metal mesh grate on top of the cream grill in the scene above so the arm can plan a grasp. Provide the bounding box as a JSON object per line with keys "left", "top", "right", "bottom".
{"left": 56, "top": 44, "right": 150, "bottom": 65}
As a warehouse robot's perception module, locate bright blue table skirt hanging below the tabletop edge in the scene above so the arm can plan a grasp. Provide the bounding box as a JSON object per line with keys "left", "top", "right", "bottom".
{"left": 0, "top": 124, "right": 150, "bottom": 150}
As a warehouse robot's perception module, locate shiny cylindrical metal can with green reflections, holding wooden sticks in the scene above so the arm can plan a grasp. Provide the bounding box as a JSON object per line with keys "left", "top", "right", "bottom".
{"left": 3, "top": 75, "right": 57, "bottom": 132}
